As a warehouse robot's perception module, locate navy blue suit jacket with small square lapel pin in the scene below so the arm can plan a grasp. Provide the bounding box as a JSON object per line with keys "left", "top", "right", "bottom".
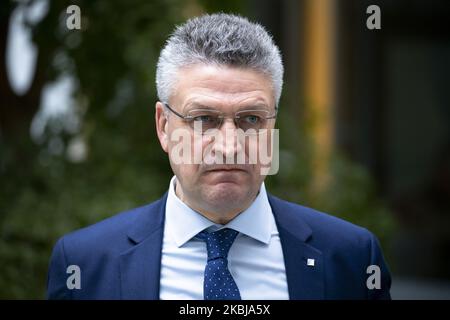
{"left": 47, "top": 193, "right": 391, "bottom": 299}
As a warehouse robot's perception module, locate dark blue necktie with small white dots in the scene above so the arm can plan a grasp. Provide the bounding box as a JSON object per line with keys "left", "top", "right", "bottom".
{"left": 197, "top": 228, "right": 241, "bottom": 300}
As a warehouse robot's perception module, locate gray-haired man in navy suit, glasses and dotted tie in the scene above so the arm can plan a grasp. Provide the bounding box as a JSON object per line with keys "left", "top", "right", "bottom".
{"left": 48, "top": 14, "right": 390, "bottom": 300}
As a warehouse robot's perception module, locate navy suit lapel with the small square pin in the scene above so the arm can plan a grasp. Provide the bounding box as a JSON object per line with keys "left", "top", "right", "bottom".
{"left": 268, "top": 195, "right": 325, "bottom": 300}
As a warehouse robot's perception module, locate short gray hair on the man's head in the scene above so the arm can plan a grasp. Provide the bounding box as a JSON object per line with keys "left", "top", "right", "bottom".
{"left": 156, "top": 13, "right": 283, "bottom": 106}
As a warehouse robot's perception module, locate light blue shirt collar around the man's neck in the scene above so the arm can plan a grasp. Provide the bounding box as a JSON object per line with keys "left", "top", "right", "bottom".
{"left": 166, "top": 176, "right": 275, "bottom": 247}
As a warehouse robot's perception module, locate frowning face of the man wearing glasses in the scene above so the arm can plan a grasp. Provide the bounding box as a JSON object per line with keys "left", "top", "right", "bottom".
{"left": 155, "top": 65, "right": 275, "bottom": 222}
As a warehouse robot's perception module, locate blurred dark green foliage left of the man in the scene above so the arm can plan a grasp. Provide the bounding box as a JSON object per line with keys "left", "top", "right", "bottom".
{"left": 0, "top": 0, "right": 179, "bottom": 298}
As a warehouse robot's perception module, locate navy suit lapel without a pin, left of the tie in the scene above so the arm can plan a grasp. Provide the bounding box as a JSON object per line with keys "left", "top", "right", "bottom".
{"left": 120, "top": 193, "right": 167, "bottom": 300}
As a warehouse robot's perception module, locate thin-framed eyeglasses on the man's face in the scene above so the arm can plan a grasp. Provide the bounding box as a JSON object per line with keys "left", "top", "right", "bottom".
{"left": 163, "top": 102, "right": 278, "bottom": 134}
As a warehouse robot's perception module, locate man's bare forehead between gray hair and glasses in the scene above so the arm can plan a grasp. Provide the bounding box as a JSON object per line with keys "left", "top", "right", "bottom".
{"left": 171, "top": 65, "right": 275, "bottom": 109}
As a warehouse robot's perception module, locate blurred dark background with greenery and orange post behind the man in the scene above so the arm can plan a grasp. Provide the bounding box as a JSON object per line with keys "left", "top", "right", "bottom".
{"left": 0, "top": 0, "right": 450, "bottom": 299}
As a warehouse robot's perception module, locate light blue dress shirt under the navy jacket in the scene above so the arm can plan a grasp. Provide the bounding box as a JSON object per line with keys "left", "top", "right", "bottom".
{"left": 160, "top": 177, "right": 289, "bottom": 300}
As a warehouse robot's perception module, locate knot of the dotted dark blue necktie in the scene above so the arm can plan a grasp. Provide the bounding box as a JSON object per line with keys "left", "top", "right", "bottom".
{"left": 197, "top": 228, "right": 238, "bottom": 261}
